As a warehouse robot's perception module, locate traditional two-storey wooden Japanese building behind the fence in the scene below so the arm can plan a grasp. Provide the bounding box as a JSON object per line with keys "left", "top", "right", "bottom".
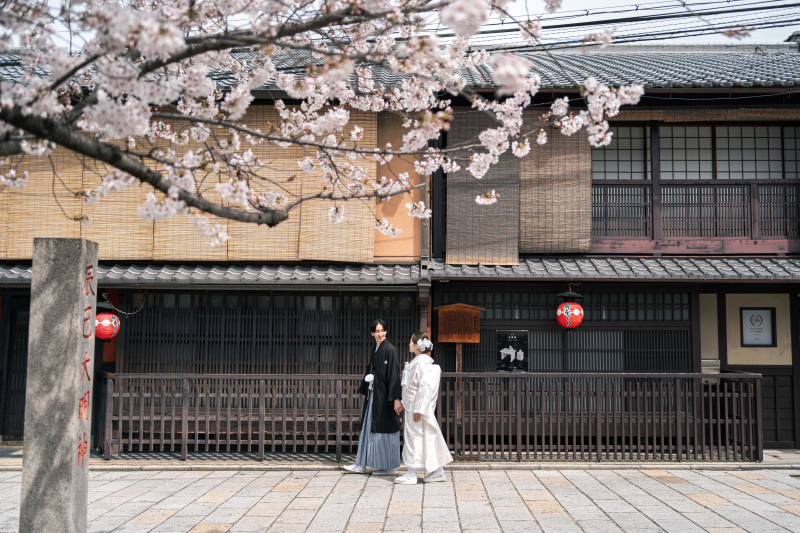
{"left": 0, "top": 37, "right": 800, "bottom": 456}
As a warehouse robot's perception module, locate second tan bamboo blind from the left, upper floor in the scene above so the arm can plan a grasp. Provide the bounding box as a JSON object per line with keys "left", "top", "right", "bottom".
{"left": 81, "top": 159, "right": 154, "bottom": 261}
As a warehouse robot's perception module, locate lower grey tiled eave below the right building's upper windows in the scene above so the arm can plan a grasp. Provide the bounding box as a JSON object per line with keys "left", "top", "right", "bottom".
{"left": 428, "top": 257, "right": 800, "bottom": 281}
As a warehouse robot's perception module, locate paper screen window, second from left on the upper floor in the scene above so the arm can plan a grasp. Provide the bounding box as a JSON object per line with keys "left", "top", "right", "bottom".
{"left": 658, "top": 126, "right": 714, "bottom": 180}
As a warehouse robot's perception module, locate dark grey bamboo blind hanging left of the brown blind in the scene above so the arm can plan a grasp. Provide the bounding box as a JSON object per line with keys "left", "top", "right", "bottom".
{"left": 446, "top": 112, "right": 520, "bottom": 265}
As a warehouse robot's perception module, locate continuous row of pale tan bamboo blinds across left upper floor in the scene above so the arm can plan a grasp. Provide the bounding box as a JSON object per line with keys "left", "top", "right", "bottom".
{"left": 0, "top": 106, "right": 382, "bottom": 262}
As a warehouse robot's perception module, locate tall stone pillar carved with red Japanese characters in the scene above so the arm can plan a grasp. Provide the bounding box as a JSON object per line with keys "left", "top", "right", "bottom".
{"left": 19, "top": 239, "right": 97, "bottom": 533}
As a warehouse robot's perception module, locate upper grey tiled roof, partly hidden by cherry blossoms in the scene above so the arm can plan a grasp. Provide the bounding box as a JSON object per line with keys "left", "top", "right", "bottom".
{"left": 0, "top": 43, "right": 800, "bottom": 91}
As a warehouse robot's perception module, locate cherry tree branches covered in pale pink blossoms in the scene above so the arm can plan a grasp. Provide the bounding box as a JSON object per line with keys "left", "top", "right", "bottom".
{"left": 0, "top": 0, "right": 643, "bottom": 246}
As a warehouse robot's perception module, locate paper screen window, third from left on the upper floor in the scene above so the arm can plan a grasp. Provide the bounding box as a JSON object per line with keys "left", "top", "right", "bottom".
{"left": 717, "top": 126, "right": 783, "bottom": 180}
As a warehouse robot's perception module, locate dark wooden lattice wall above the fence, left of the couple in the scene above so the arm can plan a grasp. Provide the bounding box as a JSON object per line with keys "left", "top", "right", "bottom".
{"left": 116, "top": 292, "right": 419, "bottom": 375}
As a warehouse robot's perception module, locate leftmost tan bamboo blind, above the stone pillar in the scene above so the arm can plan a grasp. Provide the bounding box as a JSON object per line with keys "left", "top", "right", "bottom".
{"left": 3, "top": 149, "right": 83, "bottom": 259}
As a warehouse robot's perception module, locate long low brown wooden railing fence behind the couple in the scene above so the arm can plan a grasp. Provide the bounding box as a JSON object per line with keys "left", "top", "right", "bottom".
{"left": 96, "top": 373, "right": 763, "bottom": 461}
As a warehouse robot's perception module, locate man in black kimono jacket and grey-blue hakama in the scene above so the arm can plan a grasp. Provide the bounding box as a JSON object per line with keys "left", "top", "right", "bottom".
{"left": 344, "top": 319, "right": 403, "bottom": 476}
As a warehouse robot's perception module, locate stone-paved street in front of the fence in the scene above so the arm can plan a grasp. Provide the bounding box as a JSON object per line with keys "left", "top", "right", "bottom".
{"left": 6, "top": 468, "right": 800, "bottom": 533}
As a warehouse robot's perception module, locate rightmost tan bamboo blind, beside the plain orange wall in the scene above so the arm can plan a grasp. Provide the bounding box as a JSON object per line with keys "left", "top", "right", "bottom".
{"left": 300, "top": 111, "right": 377, "bottom": 263}
